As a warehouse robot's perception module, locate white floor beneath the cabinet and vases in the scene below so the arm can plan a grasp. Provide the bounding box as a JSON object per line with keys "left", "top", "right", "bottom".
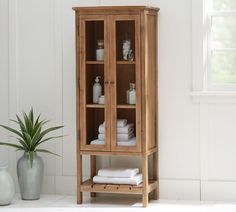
{"left": 0, "top": 195, "right": 236, "bottom": 212}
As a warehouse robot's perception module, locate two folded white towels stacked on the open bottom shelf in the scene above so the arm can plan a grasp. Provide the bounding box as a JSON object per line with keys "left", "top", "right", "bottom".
{"left": 93, "top": 168, "right": 142, "bottom": 185}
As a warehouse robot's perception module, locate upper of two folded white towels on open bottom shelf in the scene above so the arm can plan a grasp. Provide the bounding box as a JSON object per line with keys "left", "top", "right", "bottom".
{"left": 98, "top": 168, "right": 139, "bottom": 178}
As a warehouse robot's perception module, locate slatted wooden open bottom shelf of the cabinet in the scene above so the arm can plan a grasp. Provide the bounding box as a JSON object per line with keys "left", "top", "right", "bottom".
{"left": 81, "top": 179, "right": 157, "bottom": 194}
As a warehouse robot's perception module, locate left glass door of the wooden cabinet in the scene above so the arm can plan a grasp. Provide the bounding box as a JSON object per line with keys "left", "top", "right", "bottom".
{"left": 79, "top": 15, "right": 110, "bottom": 151}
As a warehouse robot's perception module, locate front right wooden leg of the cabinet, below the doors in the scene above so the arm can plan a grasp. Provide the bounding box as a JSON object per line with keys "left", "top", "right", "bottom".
{"left": 142, "top": 155, "right": 148, "bottom": 207}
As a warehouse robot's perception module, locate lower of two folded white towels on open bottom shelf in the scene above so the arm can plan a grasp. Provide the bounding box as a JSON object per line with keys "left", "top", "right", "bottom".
{"left": 93, "top": 174, "right": 142, "bottom": 185}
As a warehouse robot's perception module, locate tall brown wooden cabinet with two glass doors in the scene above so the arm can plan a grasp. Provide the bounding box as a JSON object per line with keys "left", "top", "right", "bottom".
{"left": 73, "top": 6, "right": 159, "bottom": 206}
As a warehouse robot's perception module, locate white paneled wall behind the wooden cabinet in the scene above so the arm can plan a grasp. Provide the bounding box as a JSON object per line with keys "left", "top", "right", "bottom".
{"left": 0, "top": 0, "right": 236, "bottom": 200}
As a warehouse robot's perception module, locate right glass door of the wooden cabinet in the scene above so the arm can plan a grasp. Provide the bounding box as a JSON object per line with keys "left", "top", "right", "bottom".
{"left": 110, "top": 15, "right": 141, "bottom": 152}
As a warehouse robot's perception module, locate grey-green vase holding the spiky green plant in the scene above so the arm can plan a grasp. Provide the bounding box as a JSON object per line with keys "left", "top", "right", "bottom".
{"left": 17, "top": 152, "right": 44, "bottom": 200}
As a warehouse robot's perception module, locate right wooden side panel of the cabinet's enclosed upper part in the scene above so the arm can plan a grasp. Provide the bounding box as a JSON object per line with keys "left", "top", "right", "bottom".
{"left": 145, "top": 14, "right": 157, "bottom": 149}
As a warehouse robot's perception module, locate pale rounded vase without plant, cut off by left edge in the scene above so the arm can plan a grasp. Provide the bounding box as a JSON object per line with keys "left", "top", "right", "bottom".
{"left": 0, "top": 166, "right": 15, "bottom": 206}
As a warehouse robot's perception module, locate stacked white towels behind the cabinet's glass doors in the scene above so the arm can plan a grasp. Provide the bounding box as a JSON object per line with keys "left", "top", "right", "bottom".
{"left": 90, "top": 119, "right": 136, "bottom": 146}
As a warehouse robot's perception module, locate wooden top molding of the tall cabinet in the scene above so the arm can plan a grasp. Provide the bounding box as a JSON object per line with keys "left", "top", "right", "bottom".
{"left": 73, "top": 6, "right": 160, "bottom": 12}
